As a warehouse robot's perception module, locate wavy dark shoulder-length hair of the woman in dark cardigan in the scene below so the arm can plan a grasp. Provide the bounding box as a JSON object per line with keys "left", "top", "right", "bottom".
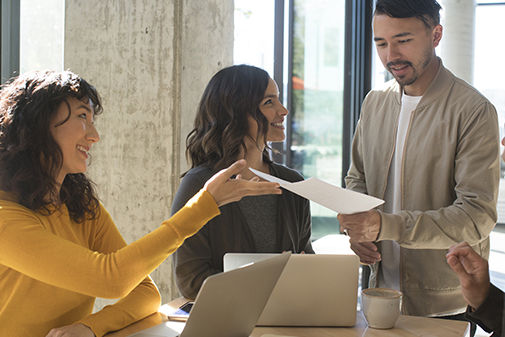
{"left": 186, "top": 64, "right": 271, "bottom": 170}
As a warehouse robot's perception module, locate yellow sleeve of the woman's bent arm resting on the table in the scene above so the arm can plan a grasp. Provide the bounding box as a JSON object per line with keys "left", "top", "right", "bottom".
{"left": 79, "top": 207, "right": 161, "bottom": 337}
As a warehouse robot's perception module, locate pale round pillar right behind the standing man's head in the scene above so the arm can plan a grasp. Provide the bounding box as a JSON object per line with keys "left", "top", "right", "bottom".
{"left": 441, "top": 0, "right": 476, "bottom": 84}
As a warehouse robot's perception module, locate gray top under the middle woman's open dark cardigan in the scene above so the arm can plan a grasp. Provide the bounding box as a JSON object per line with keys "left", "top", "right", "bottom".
{"left": 238, "top": 194, "right": 278, "bottom": 253}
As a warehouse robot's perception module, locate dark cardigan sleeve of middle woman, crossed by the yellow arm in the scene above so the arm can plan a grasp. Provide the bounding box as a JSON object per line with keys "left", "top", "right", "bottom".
{"left": 172, "top": 170, "right": 219, "bottom": 299}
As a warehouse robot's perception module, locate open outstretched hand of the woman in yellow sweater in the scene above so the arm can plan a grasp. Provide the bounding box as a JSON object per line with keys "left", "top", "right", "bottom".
{"left": 203, "top": 159, "right": 282, "bottom": 207}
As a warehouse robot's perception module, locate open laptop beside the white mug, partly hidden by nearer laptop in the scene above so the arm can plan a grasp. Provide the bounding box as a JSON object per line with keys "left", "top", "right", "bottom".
{"left": 223, "top": 253, "right": 359, "bottom": 326}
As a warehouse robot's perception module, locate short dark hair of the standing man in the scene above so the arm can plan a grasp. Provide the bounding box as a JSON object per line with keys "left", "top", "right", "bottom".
{"left": 374, "top": 0, "right": 442, "bottom": 28}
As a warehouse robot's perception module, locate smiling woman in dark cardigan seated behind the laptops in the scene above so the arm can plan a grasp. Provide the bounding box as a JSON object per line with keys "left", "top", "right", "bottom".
{"left": 172, "top": 65, "right": 313, "bottom": 299}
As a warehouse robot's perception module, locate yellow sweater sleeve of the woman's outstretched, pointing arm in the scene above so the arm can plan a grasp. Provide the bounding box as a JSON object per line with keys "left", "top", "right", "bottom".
{"left": 0, "top": 190, "right": 219, "bottom": 298}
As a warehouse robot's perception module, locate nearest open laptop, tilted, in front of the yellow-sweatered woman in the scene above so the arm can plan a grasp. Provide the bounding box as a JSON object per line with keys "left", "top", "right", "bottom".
{"left": 128, "top": 253, "right": 290, "bottom": 337}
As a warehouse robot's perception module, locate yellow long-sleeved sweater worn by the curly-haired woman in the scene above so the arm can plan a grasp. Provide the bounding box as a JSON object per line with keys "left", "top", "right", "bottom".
{"left": 0, "top": 191, "right": 219, "bottom": 337}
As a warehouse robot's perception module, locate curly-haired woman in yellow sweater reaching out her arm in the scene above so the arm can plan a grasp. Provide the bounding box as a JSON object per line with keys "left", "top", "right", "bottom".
{"left": 0, "top": 71, "right": 280, "bottom": 337}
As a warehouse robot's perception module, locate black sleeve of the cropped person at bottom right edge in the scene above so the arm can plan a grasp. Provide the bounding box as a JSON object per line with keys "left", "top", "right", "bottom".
{"left": 465, "top": 284, "right": 504, "bottom": 336}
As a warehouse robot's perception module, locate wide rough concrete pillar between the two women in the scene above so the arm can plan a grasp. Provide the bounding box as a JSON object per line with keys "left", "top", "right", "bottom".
{"left": 64, "top": 0, "right": 233, "bottom": 308}
